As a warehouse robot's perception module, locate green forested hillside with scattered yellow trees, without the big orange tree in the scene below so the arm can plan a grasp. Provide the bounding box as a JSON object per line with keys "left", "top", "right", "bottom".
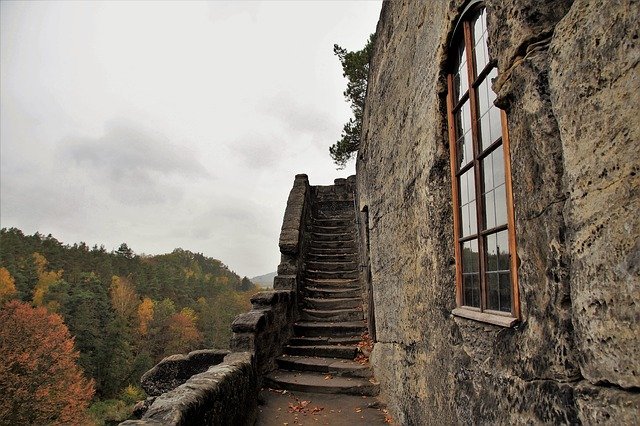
{"left": 0, "top": 228, "right": 258, "bottom": 423}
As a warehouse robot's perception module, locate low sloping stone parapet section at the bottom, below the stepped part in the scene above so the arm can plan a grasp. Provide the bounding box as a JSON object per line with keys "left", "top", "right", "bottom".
{"left": 120, "top": 353, "right": 258, "bottom": 426}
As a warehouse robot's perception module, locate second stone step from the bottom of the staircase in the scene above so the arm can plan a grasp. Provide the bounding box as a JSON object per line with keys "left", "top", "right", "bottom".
{"left": 276, "top": 355, "right": 373, "bottom": 378}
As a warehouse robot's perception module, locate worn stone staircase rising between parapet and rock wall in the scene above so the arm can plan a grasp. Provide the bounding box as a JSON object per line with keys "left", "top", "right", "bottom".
{"left": 265, "top": 186, "right": 379, "bottom": 396}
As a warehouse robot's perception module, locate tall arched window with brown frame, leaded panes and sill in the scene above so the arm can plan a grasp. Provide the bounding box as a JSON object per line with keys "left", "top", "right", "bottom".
{"left": 447, "top": 2, "right": 520, "bottom": 326}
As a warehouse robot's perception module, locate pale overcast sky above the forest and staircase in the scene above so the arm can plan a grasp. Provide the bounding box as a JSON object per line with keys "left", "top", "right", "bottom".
{"left": 0, "top": 1, "right": 381, "bottom": 276}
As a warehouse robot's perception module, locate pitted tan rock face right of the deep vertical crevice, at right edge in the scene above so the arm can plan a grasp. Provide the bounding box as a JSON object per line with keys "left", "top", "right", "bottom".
{"left": 550, "top": 0, "right": 640, "bottom": 388}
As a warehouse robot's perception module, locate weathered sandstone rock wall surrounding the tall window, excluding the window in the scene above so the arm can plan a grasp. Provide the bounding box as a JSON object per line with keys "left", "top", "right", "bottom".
{"left": 356, "top": 0, "right": 640, "bottom": 424}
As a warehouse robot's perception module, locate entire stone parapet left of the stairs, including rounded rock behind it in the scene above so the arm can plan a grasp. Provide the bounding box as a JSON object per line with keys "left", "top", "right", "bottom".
{"left": 121, "top": 175, "right": 311, "bottom": 426}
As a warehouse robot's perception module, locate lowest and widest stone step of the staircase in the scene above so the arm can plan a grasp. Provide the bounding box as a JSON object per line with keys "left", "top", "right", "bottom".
{"left": 264, "top": 370, "right": 380, "bottom": 396}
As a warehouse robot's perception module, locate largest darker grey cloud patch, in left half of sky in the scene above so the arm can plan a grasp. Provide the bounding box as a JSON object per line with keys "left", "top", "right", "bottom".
{"left": 59, "top": 120, "right": 209, "bottom": 205}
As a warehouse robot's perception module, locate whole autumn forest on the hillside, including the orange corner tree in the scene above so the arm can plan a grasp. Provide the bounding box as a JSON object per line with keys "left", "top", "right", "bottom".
{"left": 0, "top": 228, "right": 257, "bottom": 424}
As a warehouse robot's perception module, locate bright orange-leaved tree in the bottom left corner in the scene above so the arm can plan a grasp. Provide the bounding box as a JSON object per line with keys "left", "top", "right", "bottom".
{"left": 0, "top": 300, "right": 94, "bottom": 425}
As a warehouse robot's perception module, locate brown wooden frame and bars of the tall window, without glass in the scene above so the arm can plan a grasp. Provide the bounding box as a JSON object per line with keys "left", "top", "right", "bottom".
{"left": 447, "top": 1, "right": 521, "bottom": 327}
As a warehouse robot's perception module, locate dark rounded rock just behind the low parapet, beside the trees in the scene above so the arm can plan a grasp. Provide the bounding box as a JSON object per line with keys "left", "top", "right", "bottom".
{"left": 140, "top": 349, "right": 229, "bottom": 396}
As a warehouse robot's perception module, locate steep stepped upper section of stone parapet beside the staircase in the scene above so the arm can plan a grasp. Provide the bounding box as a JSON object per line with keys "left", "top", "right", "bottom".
{"left": 231, "top": 175, "right": 310, "bottom": 375}
